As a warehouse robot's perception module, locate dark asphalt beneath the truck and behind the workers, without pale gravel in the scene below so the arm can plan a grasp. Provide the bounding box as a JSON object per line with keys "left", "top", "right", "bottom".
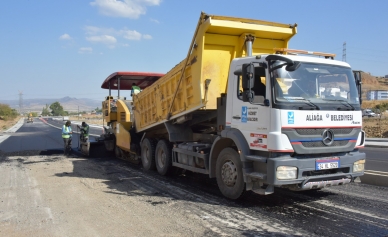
{"left": 0, "top": 117, "right": 388, "bottom": 236}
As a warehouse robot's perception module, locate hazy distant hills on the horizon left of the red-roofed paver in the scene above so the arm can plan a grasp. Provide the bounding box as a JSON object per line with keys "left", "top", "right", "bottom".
{"left": 0, "top": 96, "right": 101, "bottom": 113}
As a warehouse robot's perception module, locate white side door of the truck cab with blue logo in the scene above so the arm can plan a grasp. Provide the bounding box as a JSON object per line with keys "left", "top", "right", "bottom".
{"left": 231, "top": 67, "right": 271, "bottom": 150}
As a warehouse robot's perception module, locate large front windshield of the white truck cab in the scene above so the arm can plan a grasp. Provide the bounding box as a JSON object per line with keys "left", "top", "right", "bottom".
{"left": 272, "top": 62, "right": 360, "bottom": 110}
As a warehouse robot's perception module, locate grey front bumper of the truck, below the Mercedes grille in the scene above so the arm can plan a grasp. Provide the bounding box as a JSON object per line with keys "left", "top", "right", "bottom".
{"left": 247, "top": 152, "right": 365, "bottom": 190}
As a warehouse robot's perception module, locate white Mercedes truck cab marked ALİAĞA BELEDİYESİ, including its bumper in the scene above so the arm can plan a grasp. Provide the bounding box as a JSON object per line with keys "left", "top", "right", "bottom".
{"left": 222, "top": 54, "right": 365, "bottom": 194}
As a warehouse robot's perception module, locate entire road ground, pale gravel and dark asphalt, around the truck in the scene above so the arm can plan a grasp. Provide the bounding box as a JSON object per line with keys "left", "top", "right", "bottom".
{"left": 0, "top": 117, "right": 388, "bottom": 236}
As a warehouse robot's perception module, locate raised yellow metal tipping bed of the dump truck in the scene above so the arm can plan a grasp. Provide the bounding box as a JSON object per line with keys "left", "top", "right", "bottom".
{"left": 134, "top": 13, "right": 296, "bottom": 131}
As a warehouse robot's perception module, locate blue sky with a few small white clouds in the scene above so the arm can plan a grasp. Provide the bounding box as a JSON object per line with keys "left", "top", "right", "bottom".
{"left": 0, "top": 0, "right": 388, "bottom": 101}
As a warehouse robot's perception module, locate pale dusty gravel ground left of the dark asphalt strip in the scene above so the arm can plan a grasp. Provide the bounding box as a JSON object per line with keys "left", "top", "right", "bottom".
{"left": 0, "top": 156, "right": 212, "bottom": 236}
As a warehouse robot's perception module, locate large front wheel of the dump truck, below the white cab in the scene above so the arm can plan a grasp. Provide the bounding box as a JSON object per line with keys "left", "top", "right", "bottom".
{"left": 216, "top": 147, "right": 245, "bottom": 199}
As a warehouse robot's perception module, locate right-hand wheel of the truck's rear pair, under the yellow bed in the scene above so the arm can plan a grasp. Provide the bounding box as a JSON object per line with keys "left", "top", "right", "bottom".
{"left": 155, "top": 140, "right": 172, "bottom": 175}
